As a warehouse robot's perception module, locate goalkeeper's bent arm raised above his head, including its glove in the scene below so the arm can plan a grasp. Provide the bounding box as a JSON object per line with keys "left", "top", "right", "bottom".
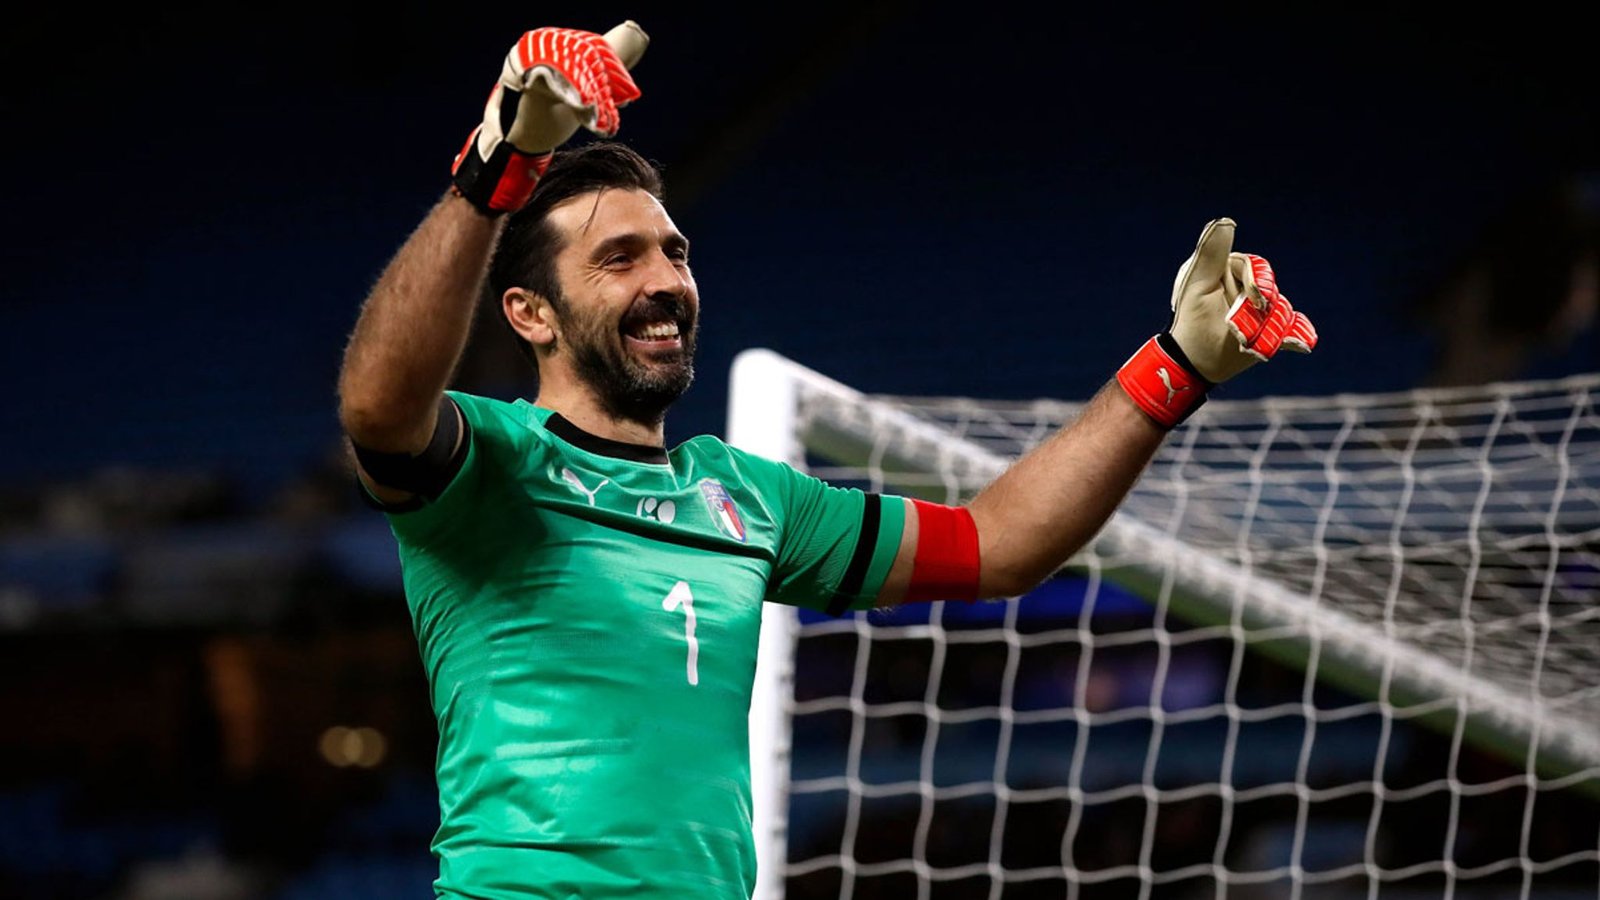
{"left": 339, "top": 22, "right": 648, "bottom": 461}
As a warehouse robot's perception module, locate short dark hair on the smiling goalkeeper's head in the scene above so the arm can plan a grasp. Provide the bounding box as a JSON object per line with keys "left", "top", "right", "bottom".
{"left": 486, "top": 141, "right": 662, "bottom": 368}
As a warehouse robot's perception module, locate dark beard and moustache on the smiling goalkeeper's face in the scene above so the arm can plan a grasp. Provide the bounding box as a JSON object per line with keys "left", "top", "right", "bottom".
{"left": 566, "top": 291, "right": 699, "bottom": 426}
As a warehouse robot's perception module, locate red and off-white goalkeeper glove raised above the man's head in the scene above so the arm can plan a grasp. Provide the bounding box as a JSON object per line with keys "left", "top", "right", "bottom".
{"left": 450, "top": 19, "right": 650, "bottom": 215}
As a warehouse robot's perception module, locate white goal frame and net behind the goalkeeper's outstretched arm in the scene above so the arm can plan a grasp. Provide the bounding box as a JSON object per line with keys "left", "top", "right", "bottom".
{"left": 730, "top": 351, "right": 1600, "bottom": 900}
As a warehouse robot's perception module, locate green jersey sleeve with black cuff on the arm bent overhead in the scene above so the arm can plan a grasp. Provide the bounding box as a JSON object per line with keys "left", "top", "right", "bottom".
{"left": 371, "top": 391, "right": 518, "bottom": 543}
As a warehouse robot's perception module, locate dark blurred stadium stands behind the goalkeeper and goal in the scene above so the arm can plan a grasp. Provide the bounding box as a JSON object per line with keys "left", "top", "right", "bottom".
{"left": 0, "top": 2, "right": 1600, "bottom": 900}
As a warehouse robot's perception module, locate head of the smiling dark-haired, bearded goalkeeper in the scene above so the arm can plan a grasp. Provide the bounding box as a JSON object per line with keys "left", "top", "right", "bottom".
{"left": 490, "top": 158, "right": 699, "bottom": 445}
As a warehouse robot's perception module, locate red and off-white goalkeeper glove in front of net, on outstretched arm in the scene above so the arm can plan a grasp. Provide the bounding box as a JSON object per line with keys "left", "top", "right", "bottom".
{"left": 1117, "top": 218, "right": 1317, "bottom": 428}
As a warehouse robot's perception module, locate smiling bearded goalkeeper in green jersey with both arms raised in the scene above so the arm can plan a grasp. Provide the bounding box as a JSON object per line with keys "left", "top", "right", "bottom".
{"left": 339, "top": 22, "right": 1317, "bottom": 900}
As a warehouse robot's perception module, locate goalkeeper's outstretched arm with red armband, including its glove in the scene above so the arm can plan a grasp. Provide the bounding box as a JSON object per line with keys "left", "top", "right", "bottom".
{"left": 878, "top": 219, "right": 1317, "bottom": 605}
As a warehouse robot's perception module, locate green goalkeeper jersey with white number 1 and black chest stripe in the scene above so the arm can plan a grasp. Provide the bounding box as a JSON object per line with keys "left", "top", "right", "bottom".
{"left": 372, "top": 392, "right": 904, "bottom": 900}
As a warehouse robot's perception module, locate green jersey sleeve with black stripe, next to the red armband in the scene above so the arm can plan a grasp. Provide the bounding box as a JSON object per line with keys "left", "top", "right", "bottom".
{"left": 745, "top": 451, "right": 906, "bottom": 615}
